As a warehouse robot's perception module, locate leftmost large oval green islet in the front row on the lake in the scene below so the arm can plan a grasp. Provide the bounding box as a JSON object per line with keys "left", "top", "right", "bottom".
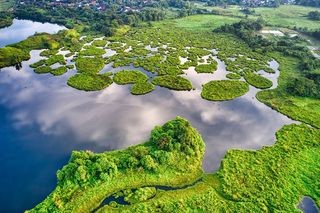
{"left": 68, "top": 73, "right": 112, "bottom": 91}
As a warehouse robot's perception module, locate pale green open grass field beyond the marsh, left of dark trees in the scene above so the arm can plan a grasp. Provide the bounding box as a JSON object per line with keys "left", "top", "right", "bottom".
{"left": 174, "top": 15, "right": 240, "bottom": 31}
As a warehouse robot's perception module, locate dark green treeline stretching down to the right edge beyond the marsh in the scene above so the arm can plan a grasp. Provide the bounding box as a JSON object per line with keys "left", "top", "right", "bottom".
{"left": 214, "top": 19, "right": 320, "bottom": 98}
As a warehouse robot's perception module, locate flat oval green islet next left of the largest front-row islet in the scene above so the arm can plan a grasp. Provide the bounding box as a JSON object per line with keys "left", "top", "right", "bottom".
{"left": 151, "top": 75, "right": 192, "bottom": 90}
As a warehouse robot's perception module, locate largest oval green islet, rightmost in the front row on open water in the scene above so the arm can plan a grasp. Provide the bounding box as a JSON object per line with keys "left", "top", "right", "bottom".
{"left": 201, "top": 80, "right": 249, "bottom": 101}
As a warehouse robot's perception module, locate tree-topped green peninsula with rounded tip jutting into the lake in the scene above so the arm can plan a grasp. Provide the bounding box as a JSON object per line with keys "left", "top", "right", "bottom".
{"left": 31, "top": 118, "right": 204, "bottom": 212}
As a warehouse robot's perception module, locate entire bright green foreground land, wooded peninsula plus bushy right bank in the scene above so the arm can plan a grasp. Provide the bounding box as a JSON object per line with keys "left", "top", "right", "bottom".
{"left": 30, "top": 118, "right": 320, "bottom": 213}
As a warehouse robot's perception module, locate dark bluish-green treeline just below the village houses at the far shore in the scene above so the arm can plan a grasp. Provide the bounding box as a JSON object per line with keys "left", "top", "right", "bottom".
{"left": 15, "top": 4, "right": 165, "bottom": 36}
